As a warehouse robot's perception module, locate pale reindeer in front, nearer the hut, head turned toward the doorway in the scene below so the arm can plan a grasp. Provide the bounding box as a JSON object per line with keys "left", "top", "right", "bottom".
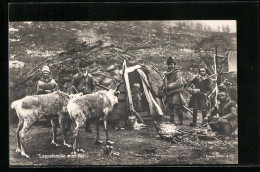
{"left": 67, "top": 82, "right": 122, "bottom": 154}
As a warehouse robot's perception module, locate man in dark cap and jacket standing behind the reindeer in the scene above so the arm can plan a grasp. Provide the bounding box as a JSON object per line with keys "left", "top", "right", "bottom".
{"left": 71, "top": 62, "right": 95, "bottom": 132}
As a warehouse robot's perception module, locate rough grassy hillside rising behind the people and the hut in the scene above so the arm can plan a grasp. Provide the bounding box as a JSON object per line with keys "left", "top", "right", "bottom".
{"left": 9, "top": 21, "right": 236, "bottom": 122}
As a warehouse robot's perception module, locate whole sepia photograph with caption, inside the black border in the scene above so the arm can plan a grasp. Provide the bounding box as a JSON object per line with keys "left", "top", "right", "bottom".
{"left": 8, "top": 20, "right": 238, "bottom": 166}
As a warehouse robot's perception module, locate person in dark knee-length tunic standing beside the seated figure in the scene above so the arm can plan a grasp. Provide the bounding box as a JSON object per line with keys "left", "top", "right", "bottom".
{"left": 187, "top": 62, "right": 213, "bottom": 127}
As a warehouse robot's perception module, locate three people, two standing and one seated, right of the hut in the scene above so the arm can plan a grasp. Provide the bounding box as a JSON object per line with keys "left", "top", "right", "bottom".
{"left": 164, "top": 57, "right": 237, "bottom": 137}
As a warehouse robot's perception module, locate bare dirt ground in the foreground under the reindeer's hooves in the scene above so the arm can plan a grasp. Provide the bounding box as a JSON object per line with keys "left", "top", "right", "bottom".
{"left": 9, "top": 117, "right": 238, "bottom": 166}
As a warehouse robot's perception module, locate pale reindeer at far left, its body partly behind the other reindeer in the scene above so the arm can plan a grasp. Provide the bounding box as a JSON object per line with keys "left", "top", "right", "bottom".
{"left": 11, "top": 90, "right": 82, "bottom": 158}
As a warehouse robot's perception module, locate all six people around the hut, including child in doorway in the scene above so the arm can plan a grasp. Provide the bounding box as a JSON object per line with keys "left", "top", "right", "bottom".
{"left": 37, "top": 57, "right": 237, "bottom": 139}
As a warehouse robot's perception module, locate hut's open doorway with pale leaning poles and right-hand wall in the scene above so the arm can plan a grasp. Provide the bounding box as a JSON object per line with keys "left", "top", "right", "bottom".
{"left": 115, "top": 60, "right": 163, "bottom": 121}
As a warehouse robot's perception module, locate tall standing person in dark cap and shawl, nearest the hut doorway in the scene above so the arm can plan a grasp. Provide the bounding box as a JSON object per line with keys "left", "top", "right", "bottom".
{"left": 164, "top": 57, "right": 186, "bottom": 125}
